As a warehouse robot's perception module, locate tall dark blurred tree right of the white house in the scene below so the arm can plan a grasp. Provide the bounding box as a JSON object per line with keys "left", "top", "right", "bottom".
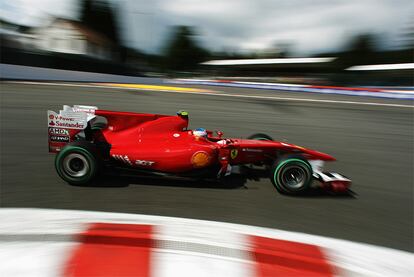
{"left": 80, "top": 0, "right": 121, "bottom": 45}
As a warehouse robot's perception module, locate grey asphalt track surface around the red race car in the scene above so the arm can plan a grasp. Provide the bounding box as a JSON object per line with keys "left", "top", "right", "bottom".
{"left": 0, "top": 82, "right": 414, "bottom": 251}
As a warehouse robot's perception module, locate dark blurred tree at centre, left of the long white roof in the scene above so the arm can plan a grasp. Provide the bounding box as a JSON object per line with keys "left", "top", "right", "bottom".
{"left": 164, "top": 26, "right": 209, "bottom": 71}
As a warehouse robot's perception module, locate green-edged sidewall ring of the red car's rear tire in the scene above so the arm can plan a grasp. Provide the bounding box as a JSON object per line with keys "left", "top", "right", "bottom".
{"left": 55, "top": 146, "right": 96, "bottom": 183}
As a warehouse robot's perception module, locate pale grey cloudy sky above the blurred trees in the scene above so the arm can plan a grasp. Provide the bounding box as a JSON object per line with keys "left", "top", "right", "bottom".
{"left": 0, "top": 0, "right": 414, "bottom": 56}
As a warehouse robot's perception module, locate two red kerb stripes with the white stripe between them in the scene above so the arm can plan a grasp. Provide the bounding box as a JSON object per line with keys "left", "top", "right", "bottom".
{"left": 63, "top": 223, "right": 334, "bottom": 277}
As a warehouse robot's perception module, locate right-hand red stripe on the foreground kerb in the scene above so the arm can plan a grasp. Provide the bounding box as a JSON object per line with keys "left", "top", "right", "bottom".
{"left": 250, "top": 236, "right": 334, "bottom": 277}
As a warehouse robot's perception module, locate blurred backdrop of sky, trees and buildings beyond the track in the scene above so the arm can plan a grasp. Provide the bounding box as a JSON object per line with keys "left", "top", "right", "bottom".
{"left": 0, "top": 0, "right": 414, "bottom": 86}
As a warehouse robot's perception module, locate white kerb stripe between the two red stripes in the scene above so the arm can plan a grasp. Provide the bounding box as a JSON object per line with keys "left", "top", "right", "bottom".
{"left": 151, "top": 222, "right": 255, "bottom": 277}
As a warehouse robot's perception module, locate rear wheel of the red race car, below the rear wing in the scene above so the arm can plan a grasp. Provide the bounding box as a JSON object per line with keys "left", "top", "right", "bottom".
{"left": 55, "top": 141, "right": 102, "bottom": 185}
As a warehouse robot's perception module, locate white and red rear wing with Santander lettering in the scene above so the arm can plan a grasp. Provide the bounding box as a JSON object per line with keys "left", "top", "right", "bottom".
{"left": 47, "top": 105, "right": 98, "bottom": 153}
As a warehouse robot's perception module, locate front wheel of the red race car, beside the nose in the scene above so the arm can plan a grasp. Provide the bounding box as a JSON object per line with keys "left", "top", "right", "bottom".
{"left": 270, "top": 156, "right": 313, "bottom": 195}
